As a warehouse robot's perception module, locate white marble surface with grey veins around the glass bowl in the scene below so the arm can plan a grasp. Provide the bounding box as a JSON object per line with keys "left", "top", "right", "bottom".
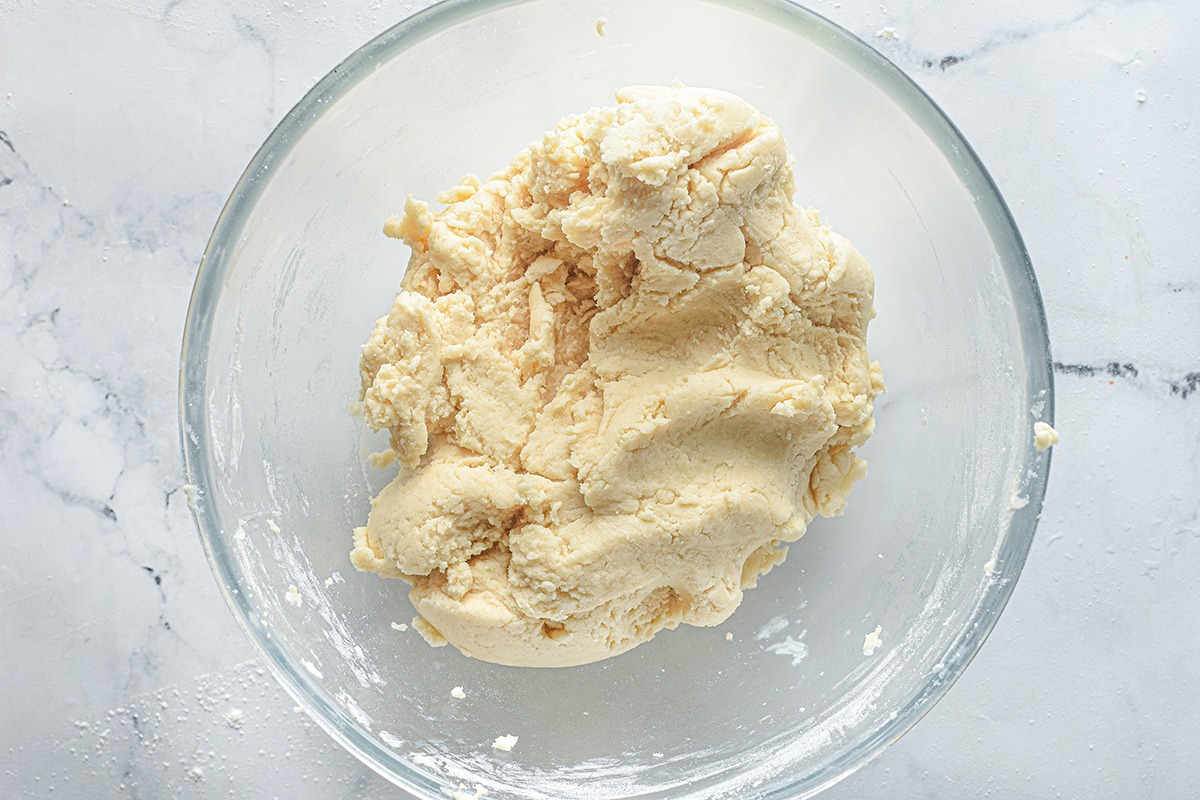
{"left": 0, "top": 0, "right": 1200, "bottom": 798}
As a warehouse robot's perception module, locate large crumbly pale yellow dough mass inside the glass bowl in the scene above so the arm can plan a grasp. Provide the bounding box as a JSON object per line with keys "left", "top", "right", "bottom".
{"left": 350, "top": 86, "right": 883, "bottom": 666}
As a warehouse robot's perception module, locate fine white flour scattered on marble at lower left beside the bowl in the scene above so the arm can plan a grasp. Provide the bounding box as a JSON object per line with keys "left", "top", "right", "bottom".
{"left": 54, "top": 661, "right": 344, "bottom": 800}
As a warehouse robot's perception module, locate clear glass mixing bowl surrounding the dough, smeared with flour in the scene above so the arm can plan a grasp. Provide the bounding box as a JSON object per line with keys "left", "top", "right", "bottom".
{"left": 180, "top": 0, "right": 1052, "bottom": 800}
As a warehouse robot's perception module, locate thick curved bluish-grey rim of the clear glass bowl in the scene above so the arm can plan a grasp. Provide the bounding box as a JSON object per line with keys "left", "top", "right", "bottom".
{"left": 179, "top": 0, "right": 1055, "bottom": 800}
